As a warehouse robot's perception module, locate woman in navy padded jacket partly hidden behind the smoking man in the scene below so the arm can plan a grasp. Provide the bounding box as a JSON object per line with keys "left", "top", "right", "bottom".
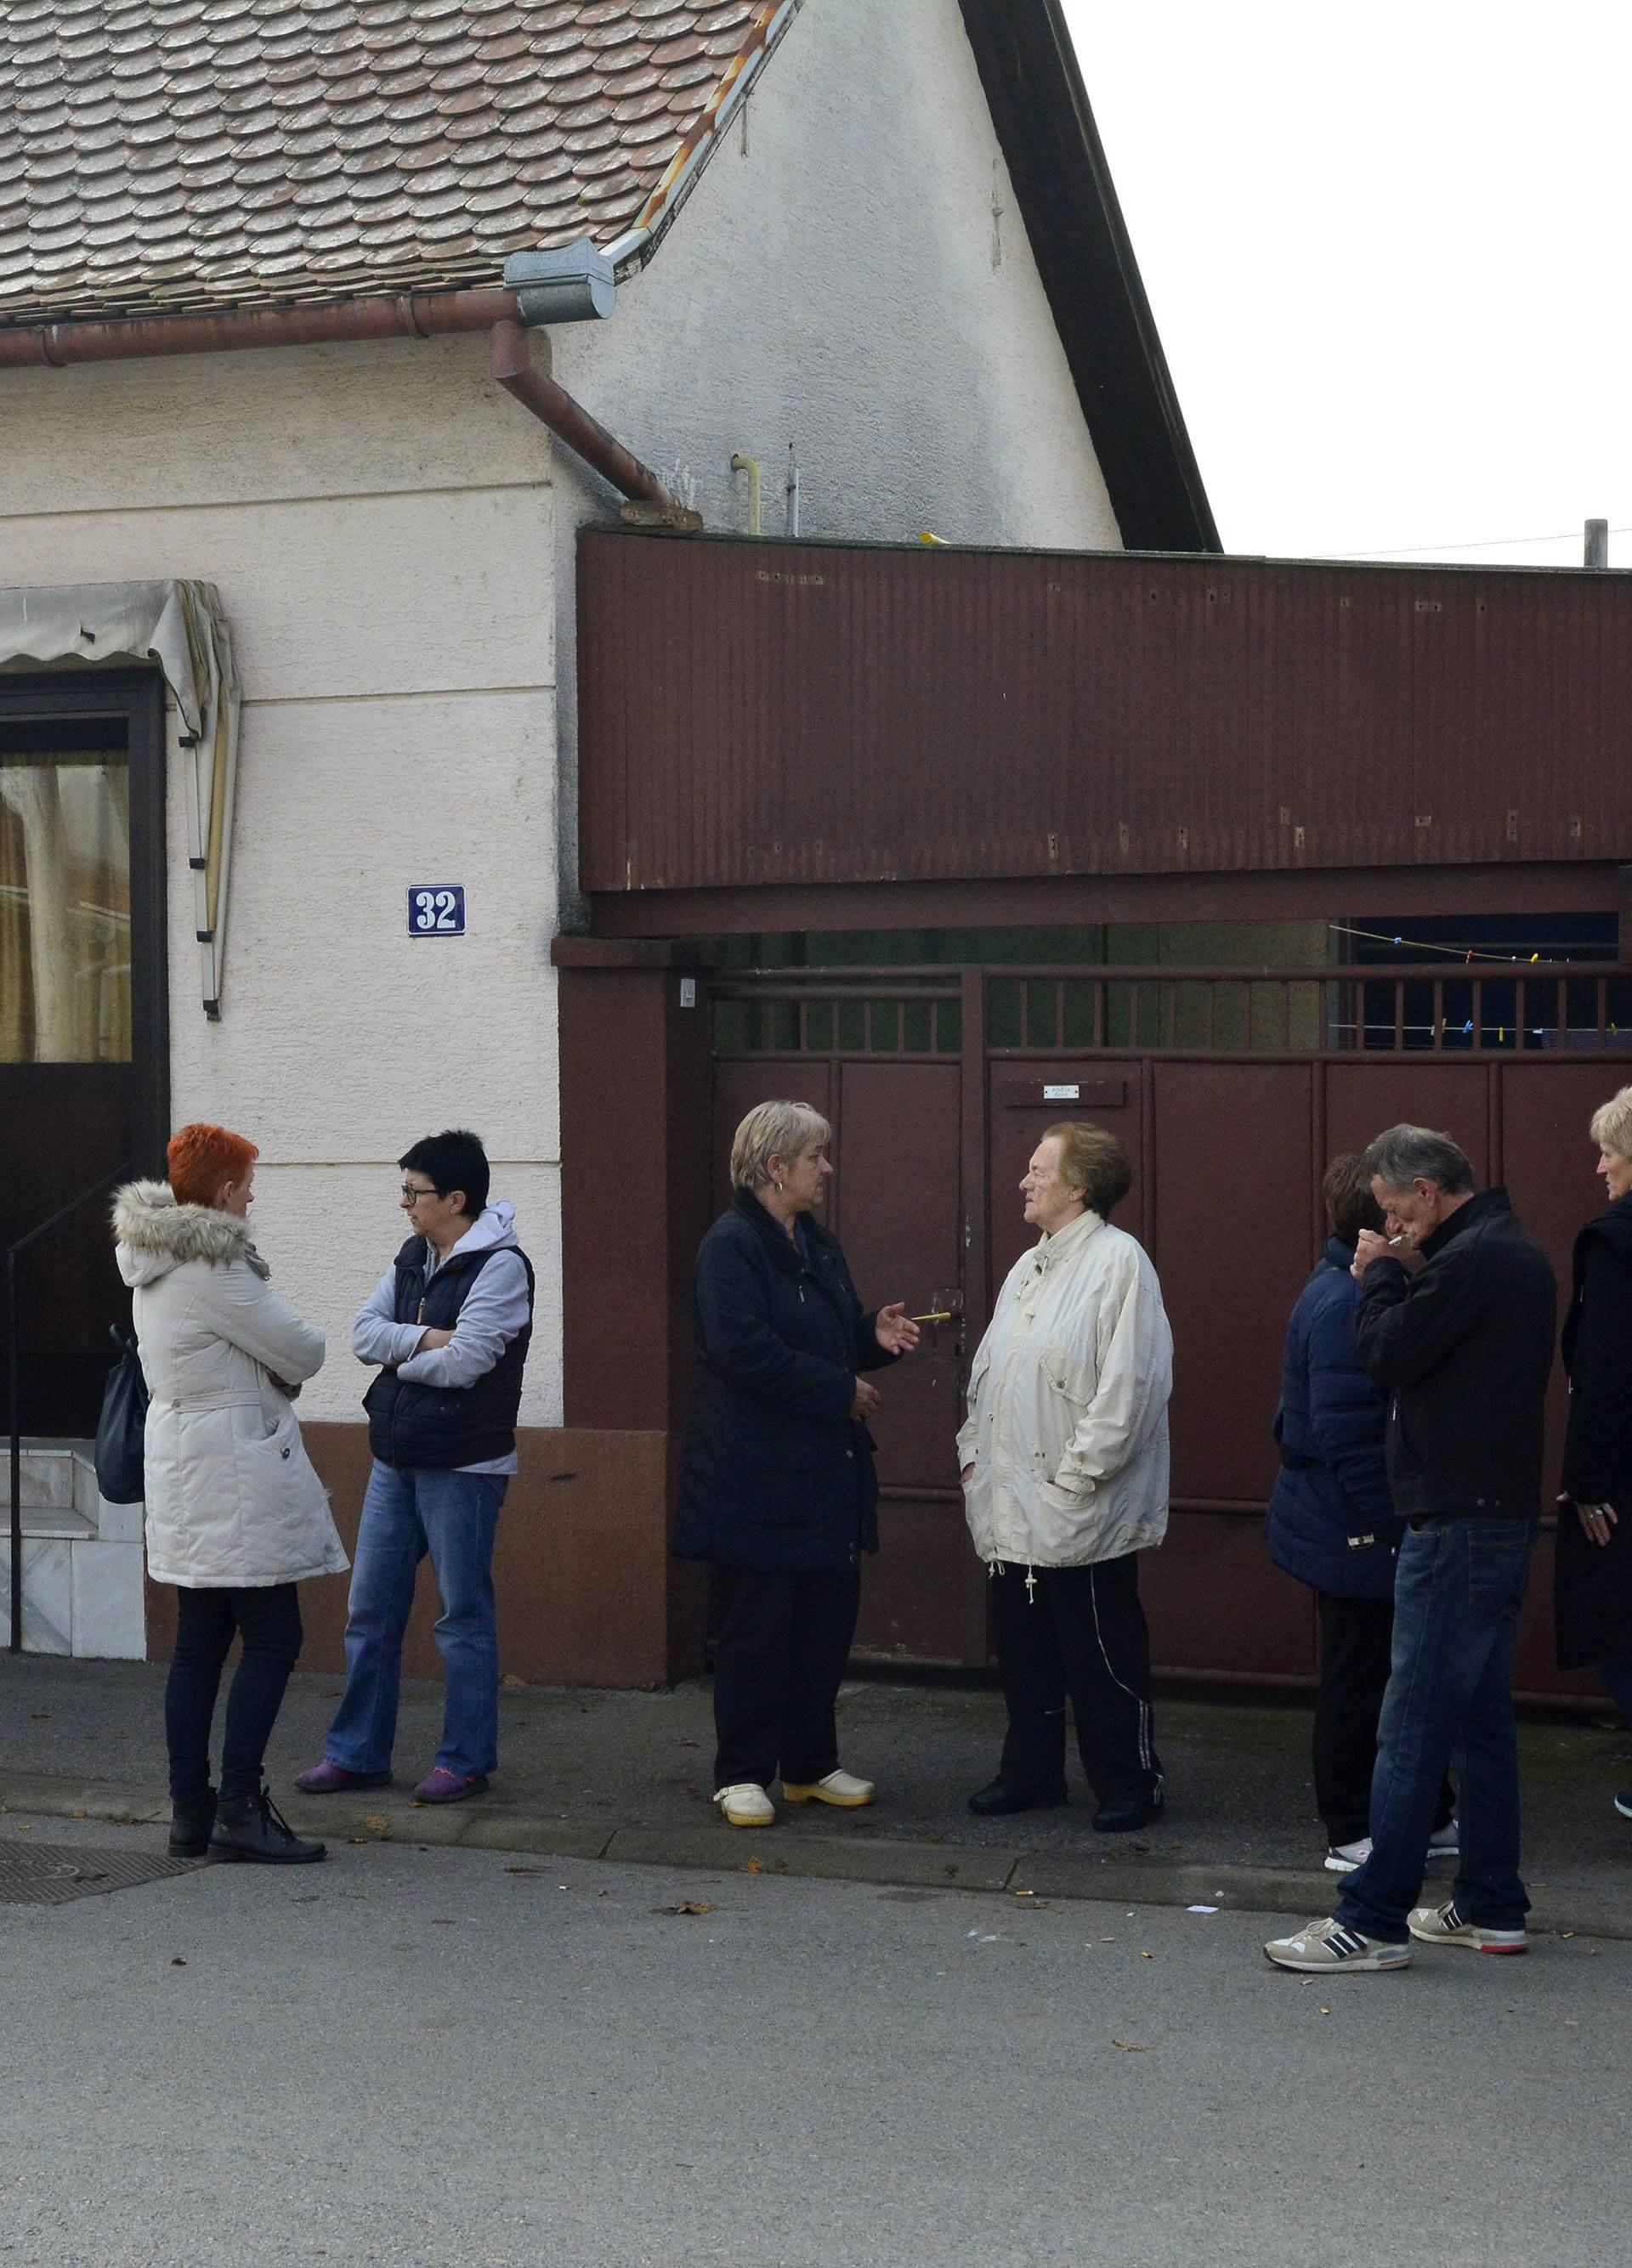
{"left": 1269, "top": 1152, "right": 1457, "bottom": 1874}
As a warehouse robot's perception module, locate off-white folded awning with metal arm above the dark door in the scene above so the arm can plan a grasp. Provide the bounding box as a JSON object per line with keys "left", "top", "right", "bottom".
{"left": 0, "top": 583, "right": 238, "bottom": 1018}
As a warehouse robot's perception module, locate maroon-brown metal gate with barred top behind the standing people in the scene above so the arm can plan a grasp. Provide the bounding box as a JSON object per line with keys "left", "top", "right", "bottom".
{"left": 711, "top": 964, "right": 1632, "bottom": 1696}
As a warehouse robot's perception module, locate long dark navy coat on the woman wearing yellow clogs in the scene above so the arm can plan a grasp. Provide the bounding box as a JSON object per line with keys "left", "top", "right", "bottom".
{"left": 674, "top": 1191, "right": 894, "bottom": 1572}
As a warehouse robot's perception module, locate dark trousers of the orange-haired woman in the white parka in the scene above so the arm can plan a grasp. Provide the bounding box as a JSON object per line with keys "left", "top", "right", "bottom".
{"left": 163, "top": 1583, "right": 302, "bottom": 1803}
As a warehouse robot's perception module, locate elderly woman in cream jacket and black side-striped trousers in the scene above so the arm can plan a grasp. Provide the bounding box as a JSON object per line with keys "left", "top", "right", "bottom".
{"left": 958, "top": 1120, "right": 1174, "bottom": 1835}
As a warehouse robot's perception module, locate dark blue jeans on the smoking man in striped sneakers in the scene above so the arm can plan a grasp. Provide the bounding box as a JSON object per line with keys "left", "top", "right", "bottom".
{"left": 1337, "top": 1519, "right": 1539, "bottom": 1943}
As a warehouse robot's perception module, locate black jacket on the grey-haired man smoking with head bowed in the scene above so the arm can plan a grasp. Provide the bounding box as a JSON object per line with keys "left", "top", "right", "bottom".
{"left": 1355, "top": 1189, "right": 1557, "bottom": 1519}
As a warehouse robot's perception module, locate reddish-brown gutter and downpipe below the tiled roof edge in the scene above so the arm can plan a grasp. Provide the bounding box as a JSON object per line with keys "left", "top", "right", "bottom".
{"left": 0, "top": 291, "right": 681, "bottom": 511}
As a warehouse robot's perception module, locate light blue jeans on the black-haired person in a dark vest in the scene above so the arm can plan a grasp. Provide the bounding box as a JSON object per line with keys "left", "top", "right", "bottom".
{"left": 325, "top": 1461, "right": 508, "bottom": 1778}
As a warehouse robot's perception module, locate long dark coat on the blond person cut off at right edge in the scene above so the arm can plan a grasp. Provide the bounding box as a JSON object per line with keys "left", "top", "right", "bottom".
{"left": 1553, "top": 1197, "right": 1632, "bottom": 1669}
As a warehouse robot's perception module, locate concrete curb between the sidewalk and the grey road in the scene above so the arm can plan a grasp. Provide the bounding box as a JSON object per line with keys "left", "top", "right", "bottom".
{"left": 0, "top": 1771, "right": 1632, "bottom": 1939}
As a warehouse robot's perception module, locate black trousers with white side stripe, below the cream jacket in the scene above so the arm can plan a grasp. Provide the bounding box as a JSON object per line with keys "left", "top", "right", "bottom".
{"left": 988, "top": 1552, "right": 1162, "bottom": 1803}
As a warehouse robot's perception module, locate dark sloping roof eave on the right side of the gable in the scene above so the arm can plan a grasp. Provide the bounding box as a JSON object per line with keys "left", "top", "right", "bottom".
{"left": 958, "top": 0, "right": 1223, "bottom": 551}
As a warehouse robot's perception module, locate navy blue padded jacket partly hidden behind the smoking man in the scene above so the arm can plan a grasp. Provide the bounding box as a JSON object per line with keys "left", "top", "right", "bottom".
{"left": 1269, "top": 1236, "right": 1401, "bottom": 1599}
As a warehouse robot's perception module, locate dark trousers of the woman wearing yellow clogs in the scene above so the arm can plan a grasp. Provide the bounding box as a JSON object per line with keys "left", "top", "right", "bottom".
{"left": 715, "top": 1567, "right": 860, "bottom": 1787}
